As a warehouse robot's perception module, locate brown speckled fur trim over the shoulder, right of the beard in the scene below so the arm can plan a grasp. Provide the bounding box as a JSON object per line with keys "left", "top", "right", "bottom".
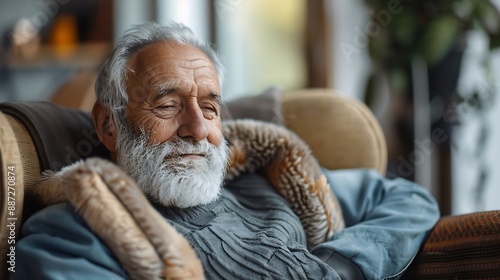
{"left": 223, "top": 120, "right": 345, "bottom": 249}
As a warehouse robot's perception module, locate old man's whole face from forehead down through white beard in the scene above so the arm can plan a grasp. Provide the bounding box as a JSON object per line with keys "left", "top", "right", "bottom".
{"left": 112, "top": 42, "right": 228, "bottom": 208}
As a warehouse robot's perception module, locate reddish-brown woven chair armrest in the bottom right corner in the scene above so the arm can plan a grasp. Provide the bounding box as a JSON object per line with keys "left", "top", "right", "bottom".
{"left": 405, "top": 210, "right": 500, "bottom": 279}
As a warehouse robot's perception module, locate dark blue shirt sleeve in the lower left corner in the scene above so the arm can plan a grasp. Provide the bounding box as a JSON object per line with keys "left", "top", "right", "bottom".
{"left": 10, "top": 203, "right": 126, "bottom": 280}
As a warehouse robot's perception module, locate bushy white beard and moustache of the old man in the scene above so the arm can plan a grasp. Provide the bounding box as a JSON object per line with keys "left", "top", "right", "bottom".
{"left": 117, "top": 124, "right": 228, "bottom": 208}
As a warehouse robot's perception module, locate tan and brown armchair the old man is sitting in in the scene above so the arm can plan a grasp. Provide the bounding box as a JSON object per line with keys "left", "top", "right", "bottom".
{"left": 0, "top": 89, "right": 500, "bottom": 279}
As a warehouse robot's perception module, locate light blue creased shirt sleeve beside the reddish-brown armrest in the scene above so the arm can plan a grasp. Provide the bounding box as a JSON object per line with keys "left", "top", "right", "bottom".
{"left": 312, "top": 169, "right": 440, "bottom": 279}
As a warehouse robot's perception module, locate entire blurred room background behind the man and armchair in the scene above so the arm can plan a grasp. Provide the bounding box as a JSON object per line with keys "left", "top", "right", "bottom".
{"left": 0, "top": 0, "right": 500, "bottom": 214}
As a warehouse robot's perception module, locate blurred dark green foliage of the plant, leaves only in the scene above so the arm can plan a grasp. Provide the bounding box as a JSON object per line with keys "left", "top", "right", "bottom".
{"left": 364, "top": 0, "right": 500, "bottom": 104}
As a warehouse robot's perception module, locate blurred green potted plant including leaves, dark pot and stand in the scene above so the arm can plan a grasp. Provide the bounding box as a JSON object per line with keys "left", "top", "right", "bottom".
{"left": 364, "top": 0, "right": 500, "bottom": 213}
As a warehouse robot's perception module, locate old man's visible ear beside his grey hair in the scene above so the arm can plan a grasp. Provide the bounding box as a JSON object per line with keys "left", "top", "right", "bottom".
{"left": 92, "top": 101, "right": 118, "bottom": 154}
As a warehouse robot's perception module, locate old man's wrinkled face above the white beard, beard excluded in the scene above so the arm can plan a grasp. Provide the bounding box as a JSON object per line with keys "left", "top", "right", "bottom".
{"left": 126, "top": 42, "right": 222, "bottom": 149}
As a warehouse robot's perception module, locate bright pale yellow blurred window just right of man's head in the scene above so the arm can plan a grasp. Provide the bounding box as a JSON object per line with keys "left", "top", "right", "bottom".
{"left": 213, "top": 0, "right": 307, "bottom": 99}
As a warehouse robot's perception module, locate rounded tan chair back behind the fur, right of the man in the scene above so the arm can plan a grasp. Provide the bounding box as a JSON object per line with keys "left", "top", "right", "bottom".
{"left": 282, "top": 89, "right": 387, "bottom": 174}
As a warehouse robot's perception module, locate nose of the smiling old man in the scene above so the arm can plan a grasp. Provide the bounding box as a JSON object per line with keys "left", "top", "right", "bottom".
{"left": 177, "top": 106, "right": 209, "bottom": 141}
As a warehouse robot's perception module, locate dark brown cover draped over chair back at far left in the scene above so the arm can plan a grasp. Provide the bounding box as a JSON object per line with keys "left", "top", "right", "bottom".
{"left": 0, "top": 101, "right": 109, "bottom": 171}
